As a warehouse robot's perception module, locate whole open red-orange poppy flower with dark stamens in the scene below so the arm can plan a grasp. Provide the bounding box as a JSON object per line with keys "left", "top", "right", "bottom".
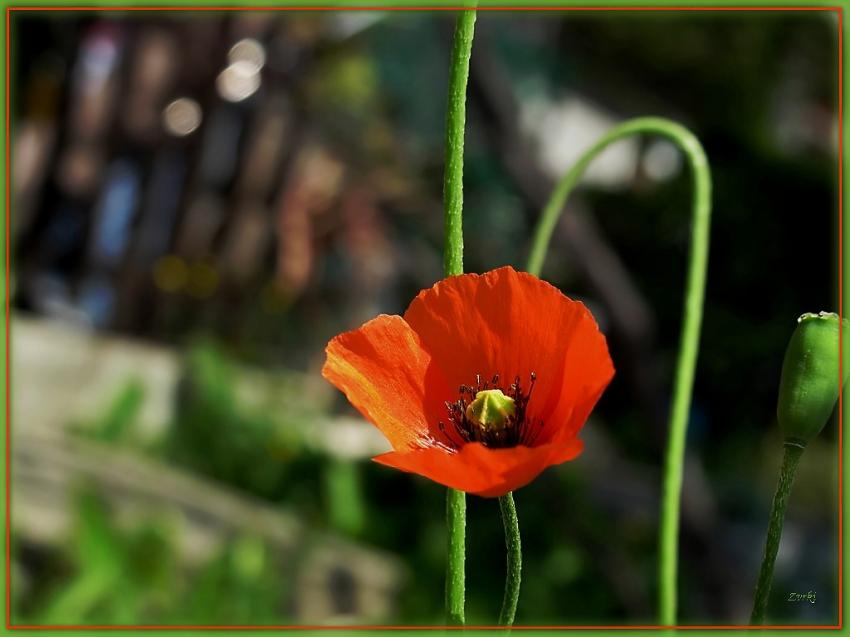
{"left": 322, "top": 267, "right": 614, "bottom": 497}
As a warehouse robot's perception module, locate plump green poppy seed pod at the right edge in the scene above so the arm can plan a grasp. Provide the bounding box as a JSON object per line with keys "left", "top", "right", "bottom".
{"left": 776, "top": 312, "right": 850, "bottom": 447}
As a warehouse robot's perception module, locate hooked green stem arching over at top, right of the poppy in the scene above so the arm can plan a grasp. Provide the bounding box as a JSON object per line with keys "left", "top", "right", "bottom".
{"left": 527, "top": 117, "right": 711, "bottom": 625}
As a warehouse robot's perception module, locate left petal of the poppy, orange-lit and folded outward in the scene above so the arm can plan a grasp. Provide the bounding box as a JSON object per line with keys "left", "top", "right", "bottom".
{"left": 322, "top": 314, "right": 450, "bottom": 451}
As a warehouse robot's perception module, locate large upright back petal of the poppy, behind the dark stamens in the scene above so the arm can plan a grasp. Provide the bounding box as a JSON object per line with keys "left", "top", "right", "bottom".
{"left": 404, "top": 267, "right": 614, "bottom": 443}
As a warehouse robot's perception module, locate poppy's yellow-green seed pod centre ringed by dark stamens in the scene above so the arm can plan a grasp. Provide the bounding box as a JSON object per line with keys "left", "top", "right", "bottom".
{"left": 440, "top": 372, "right": 543, "bottom": 449}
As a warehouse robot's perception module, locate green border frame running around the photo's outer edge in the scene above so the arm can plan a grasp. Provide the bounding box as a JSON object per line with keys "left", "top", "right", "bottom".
{"left": 0, "top": 0, "right": 850, "bottom": 637}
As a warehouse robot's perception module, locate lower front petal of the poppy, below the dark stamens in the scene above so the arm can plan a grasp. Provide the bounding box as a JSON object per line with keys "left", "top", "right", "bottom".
{"left": 373, "top": 438, "right": 582, "bottom": 498}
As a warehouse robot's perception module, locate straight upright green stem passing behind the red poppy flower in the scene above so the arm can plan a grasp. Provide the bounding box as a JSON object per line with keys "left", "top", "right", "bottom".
{"left": 443, "top": 11, "right": 475, "bottom": 625}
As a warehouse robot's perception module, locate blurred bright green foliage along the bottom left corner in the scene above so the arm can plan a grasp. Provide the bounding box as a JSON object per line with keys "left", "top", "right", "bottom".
{"left": 18, "top": 489, "right": 285, "bottom": 625}
